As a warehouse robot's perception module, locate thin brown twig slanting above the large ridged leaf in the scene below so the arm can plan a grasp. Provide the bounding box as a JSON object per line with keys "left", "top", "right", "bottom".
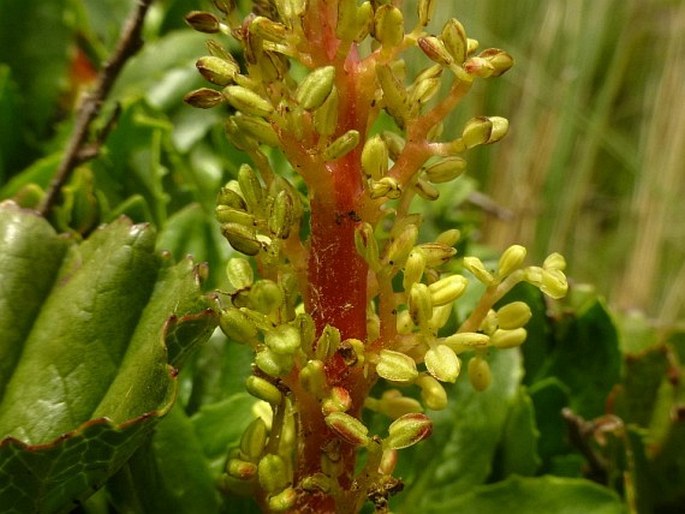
{"left": 38, "top": 0, "right": 153, "bottom": 216}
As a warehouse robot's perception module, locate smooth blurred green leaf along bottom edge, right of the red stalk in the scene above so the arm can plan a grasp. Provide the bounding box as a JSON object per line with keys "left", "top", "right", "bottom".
{"left": 422, "top": 476, "right": 625, "bottom": 514}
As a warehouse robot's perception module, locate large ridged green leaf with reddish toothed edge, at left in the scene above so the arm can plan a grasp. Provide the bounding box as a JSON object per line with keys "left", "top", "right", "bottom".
{"left": 0, "top": 202, "right": 216, "bottom": 512}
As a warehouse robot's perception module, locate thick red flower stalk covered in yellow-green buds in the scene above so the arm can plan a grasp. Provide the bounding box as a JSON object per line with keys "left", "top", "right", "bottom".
{"left": 186, "top": 0, "right": 567, "bottom": 513}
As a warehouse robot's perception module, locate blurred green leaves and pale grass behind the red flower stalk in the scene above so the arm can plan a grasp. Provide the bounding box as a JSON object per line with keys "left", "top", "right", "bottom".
{"left": 0, "top": 0, "right": 685, "bottom": 514}
